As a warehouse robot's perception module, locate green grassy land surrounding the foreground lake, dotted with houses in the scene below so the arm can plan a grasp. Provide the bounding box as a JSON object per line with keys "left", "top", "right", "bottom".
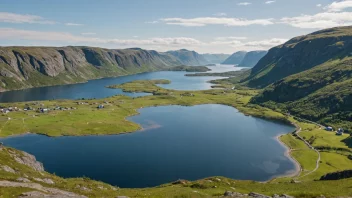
{"left": 0, "top": 80, "right": 352, "bottom": 197}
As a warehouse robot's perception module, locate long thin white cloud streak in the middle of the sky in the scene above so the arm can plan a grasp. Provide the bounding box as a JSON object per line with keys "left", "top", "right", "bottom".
{"left": 161, "top": 17, "right": 273, "bottom": 27}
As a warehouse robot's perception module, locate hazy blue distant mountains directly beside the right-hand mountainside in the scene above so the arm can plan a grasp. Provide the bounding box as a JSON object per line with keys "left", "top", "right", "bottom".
{"left": 222, "top": 51, "right": 267, "bottom": 67}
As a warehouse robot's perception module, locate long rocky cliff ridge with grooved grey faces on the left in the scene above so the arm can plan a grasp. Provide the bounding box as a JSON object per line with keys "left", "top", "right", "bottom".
{"left": 0, "top": 47, "right": 186, "bottom": 91}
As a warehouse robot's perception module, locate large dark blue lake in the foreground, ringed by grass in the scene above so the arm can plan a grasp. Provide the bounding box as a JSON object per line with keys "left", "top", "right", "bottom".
{"left": 1, "top": 105, "right": 295, "bottom": 187}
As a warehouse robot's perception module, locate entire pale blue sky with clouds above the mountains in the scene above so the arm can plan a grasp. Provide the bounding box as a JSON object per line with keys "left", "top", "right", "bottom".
{"left": 0, "top": 0, "right": 352, "bottom": 54}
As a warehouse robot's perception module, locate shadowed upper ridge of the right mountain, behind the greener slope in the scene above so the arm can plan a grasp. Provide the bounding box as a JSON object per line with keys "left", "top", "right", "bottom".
{"left": 246, "top": 26, "right": 352, "bottom": 88}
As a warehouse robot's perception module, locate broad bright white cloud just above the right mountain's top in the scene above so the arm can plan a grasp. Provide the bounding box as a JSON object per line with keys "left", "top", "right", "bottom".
{"left": 280, "top": 12, "right": 352, "bottom": 29}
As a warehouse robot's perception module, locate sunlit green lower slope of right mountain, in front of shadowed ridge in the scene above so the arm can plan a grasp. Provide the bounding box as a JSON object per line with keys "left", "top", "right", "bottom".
{"left": 252, "top": 57, "right": 352, "bottom": 130}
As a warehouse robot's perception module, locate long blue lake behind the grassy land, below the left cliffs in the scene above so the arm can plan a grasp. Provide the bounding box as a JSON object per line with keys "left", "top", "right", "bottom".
{"left": 0, "top": 65, "right": 236, "bottom": 102}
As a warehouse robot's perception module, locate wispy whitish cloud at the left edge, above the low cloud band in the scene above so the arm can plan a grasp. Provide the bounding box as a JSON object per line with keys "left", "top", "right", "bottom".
{"left": 0, "top": 12, "right": 55, "bottom": 24}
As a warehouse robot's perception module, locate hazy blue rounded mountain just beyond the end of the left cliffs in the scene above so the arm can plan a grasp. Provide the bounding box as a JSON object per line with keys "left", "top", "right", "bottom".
{"left": 163, "top": 49, "right": 209, "bottom": 66}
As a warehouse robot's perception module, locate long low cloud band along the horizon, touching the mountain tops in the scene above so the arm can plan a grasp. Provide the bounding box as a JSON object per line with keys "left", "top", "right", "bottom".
{"left": 0, "top": 28, "right": 286, "bottom": 53}
